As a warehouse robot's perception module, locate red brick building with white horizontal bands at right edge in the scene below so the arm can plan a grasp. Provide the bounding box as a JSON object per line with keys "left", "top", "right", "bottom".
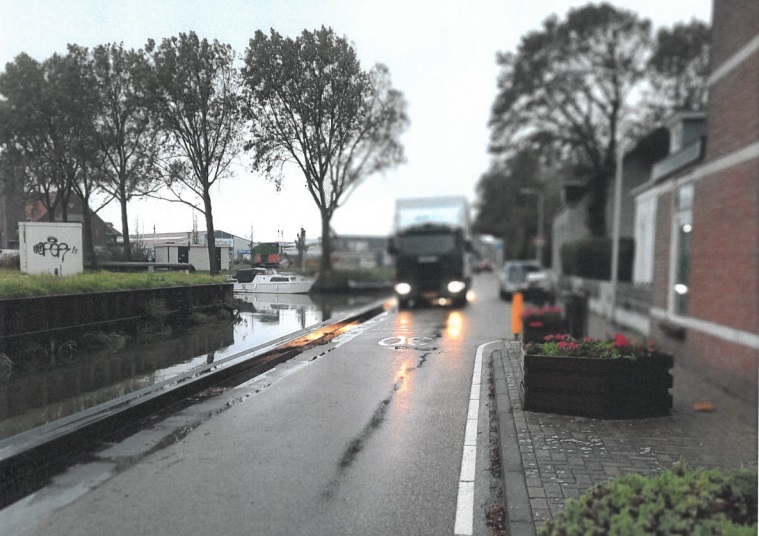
{"left": 636, "top": 0, "right": 759, "bottom": 399}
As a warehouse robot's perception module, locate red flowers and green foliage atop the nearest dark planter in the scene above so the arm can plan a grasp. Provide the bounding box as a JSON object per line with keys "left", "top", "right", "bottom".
{"left": 524, "top": 333, "right": 664, "bottom": 359}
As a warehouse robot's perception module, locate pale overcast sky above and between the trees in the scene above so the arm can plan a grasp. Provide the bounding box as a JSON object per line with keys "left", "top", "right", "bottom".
{"left": 0, "top": 0, "right": 711, "bottom": 241}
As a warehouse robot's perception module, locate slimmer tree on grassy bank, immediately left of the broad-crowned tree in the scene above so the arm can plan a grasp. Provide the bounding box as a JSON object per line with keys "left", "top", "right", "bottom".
{"left": 141, "top": 32, "right": 243, "bottom": 274}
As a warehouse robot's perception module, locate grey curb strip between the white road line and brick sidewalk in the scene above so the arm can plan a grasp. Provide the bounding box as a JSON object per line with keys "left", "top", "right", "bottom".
{"left": 491, "top": 341, "right": 535, "bottom": 536}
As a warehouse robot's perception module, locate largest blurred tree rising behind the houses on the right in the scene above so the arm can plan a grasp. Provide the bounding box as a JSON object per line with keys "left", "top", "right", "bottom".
{"left": 490, "top": 3, "right": 651, "bottom": 235}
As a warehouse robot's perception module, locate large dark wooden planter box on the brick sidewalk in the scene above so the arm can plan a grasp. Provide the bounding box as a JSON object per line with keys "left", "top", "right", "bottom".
{"left": 520, "top": 354, "right": 673, "bottom": 419}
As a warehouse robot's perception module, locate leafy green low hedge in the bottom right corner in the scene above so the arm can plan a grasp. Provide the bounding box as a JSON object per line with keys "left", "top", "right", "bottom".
{"left": 538, "top": 463, "right": 757, "bottom": 536}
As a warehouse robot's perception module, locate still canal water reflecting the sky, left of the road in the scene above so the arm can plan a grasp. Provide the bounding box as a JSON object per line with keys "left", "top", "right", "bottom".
{"left": 0, "top": 294, "right": 382, "bottom": 440}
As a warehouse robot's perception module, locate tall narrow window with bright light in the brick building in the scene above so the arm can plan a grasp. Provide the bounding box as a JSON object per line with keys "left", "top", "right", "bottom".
{"left": 672, "top": 184, "right": 693, "bottom": 315}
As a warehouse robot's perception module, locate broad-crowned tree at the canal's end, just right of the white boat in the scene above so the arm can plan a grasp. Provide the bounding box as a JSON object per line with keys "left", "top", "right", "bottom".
{"left": 243, "top": 27, "right": 408, "bottom": 273}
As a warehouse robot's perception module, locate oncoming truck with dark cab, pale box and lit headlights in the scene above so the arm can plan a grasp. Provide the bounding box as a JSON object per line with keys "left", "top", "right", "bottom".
{"left": 389, "top": 196, "right": 472, "bottom": 309}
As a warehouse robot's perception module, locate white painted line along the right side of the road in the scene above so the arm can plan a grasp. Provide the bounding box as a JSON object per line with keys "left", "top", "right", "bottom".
{"left": 453, "top": 341, "right": 500, "bottom": 536}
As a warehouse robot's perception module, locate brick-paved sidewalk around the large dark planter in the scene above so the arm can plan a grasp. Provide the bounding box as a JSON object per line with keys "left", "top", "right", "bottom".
{"left": 492, "top": 341, "right": 757, "bottom": 536}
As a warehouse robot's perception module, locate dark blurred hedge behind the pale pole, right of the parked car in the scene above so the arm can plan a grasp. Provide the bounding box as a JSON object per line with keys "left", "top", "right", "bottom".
{"left": 561, "top": 237, "right": 635, "bottom": 281}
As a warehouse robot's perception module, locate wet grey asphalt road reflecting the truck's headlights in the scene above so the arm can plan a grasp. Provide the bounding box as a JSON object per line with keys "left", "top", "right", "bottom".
{"left": 5, "top": 274, "right": 510, "bottom": 536}
